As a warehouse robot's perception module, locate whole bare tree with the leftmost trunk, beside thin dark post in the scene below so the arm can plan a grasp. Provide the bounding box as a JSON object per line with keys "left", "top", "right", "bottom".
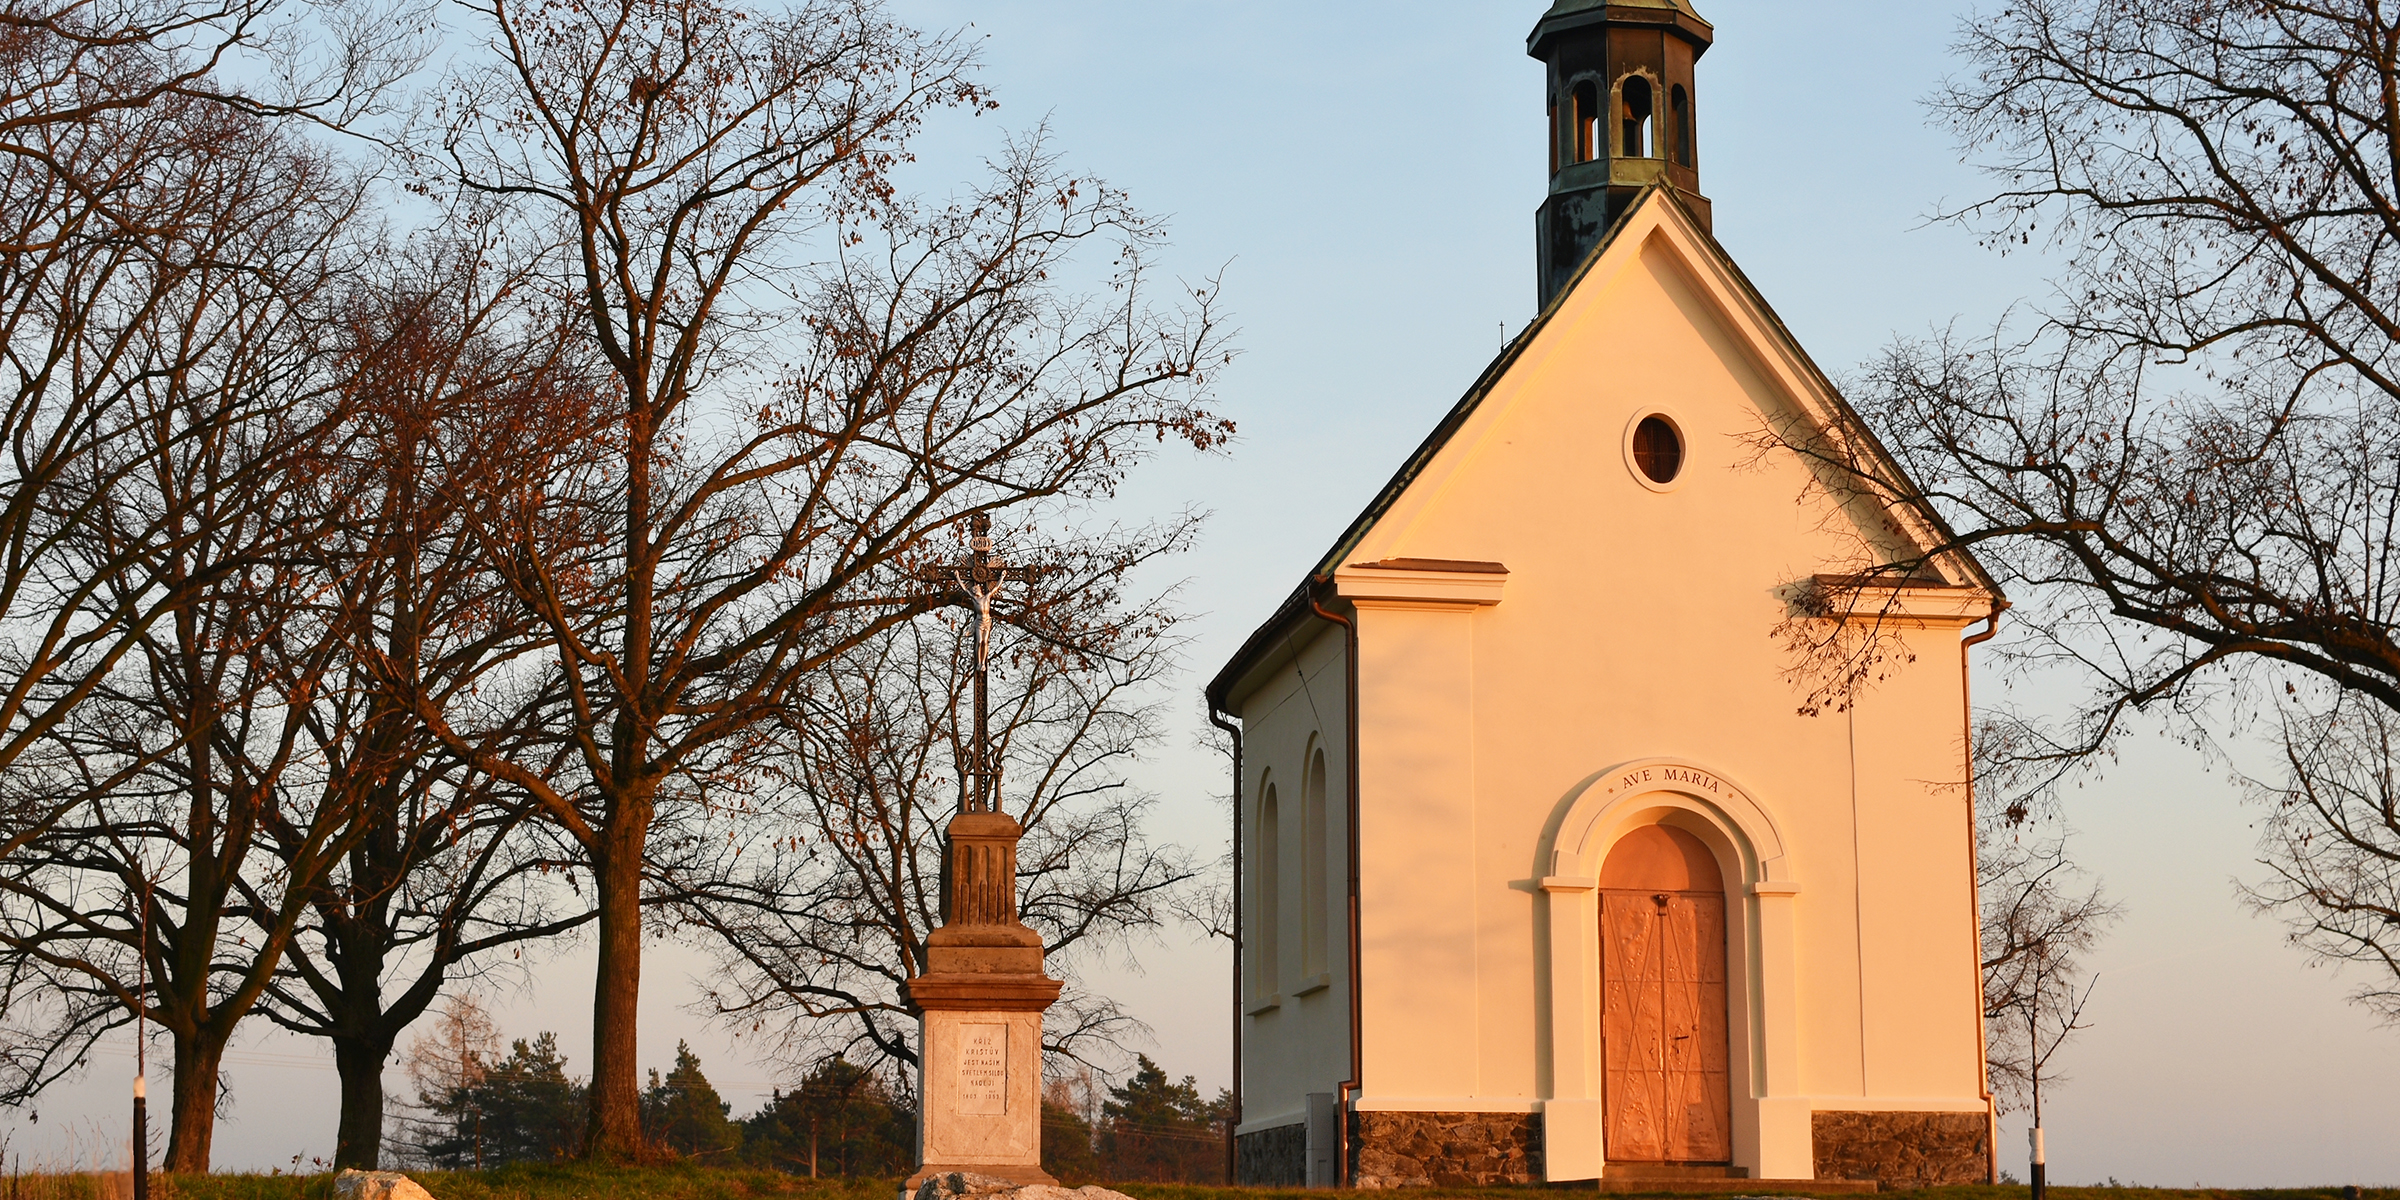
{"left": 0, "top": 100, "right": 379, "bottom": 1171}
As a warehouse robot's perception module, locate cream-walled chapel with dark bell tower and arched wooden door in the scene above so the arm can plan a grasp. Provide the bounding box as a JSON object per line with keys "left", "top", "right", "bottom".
{"left": 1207, "top": 0, "right": 2004, "bottom": 1190}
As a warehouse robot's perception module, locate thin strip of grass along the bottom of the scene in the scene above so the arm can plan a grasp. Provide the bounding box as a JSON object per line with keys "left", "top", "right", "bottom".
{"left": 0, "top": 1164, "right": 2400, "bottom": 1200}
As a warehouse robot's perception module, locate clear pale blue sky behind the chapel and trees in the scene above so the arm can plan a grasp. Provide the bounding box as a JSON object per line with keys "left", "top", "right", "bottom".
{"left": 5, "top": 0, "right": 2400, "bottom": 1186}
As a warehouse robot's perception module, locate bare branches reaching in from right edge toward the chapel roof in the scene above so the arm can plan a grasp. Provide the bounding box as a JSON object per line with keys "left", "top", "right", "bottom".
{"left": 1774, "top": 0, "right": 2400, "bottom": 998}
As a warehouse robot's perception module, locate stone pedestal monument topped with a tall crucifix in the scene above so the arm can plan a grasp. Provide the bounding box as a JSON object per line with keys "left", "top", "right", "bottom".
{"left": 902, "top": 516, "right": 1058, "bottom": 1195}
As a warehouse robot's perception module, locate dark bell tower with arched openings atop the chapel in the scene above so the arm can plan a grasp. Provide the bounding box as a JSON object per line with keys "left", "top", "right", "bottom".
{"left": 1524, "top": 0, "right": 1714, "bottom": 305}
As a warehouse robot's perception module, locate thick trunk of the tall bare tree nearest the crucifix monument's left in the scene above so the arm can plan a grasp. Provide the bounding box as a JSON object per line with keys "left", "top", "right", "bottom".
{"left": 583, "top": 797, "right": 650, "bottom": 1162}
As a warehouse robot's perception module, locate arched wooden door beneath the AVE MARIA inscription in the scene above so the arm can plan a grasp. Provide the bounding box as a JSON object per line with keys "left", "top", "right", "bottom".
{"left": 1598, "top": 826, "right": 1733, "bottom": 1164}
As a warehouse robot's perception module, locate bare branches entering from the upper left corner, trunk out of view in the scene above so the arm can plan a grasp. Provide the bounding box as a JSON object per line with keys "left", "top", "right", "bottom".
{"left": 0, "top": 0, "right": 425, "bottom": 852}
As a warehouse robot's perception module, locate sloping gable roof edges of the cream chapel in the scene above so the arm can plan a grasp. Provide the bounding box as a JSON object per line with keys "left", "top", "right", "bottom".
{"left": 1205, "top": 182, "right": 2002, "bottom": 710}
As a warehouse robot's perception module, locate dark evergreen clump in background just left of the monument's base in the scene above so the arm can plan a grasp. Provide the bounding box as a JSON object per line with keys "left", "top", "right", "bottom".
{"left": 742, "top": 1056, "right": 917, "bottom": 1178}
